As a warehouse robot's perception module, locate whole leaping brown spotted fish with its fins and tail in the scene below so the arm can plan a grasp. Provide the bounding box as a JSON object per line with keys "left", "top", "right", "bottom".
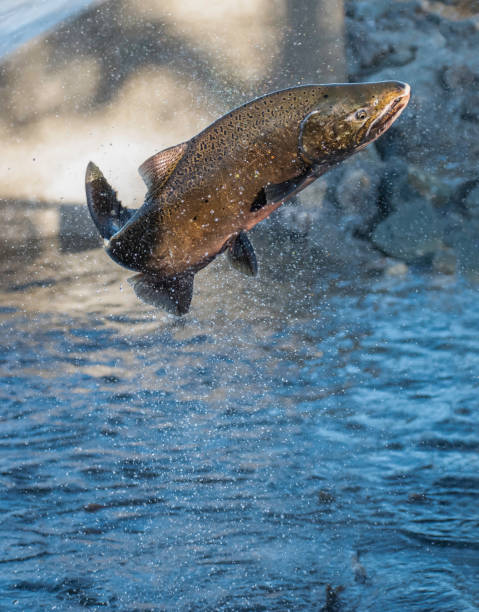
{"left": 85, "top": 81, "right": 410, "bottom": 315}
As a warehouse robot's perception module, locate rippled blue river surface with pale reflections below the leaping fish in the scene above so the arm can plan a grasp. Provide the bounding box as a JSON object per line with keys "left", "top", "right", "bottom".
{"left": 0, "top": 240, "right": 479, "bottom": 610}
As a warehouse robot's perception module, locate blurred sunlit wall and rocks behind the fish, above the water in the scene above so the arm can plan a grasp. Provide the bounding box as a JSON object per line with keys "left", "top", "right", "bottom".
{"left": 0, "top": 0, "right": 479, "bottom": 274}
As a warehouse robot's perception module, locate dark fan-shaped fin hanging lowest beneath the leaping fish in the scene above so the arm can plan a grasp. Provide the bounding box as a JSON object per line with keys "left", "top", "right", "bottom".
{"left": 128, "top": 272, "right": 193, "bottom": 315}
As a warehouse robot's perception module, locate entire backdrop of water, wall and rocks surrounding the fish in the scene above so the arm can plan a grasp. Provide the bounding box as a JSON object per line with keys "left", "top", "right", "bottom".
{"left": 0, "top": 0, "right": 479, "bottom": 612}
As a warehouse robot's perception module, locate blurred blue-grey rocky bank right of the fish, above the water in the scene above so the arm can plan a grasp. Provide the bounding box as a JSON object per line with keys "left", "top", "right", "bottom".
{"left": 280, "top": 1, "right": 479, "bottom": 274}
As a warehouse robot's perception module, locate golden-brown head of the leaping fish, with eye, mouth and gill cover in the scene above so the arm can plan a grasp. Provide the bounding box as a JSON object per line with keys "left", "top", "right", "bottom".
{"left": 299, "top": 81, "right": 410, "bottom": 167}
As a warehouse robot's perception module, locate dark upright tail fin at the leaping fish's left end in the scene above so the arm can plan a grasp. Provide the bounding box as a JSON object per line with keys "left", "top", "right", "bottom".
{"left": 85, "top": 162, "right": 136, "bottom": 240}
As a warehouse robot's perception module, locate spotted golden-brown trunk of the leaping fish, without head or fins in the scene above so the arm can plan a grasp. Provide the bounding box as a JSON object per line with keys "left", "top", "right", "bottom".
{"left": 111, "top": 88, "right": 321, "bottom": 275}
